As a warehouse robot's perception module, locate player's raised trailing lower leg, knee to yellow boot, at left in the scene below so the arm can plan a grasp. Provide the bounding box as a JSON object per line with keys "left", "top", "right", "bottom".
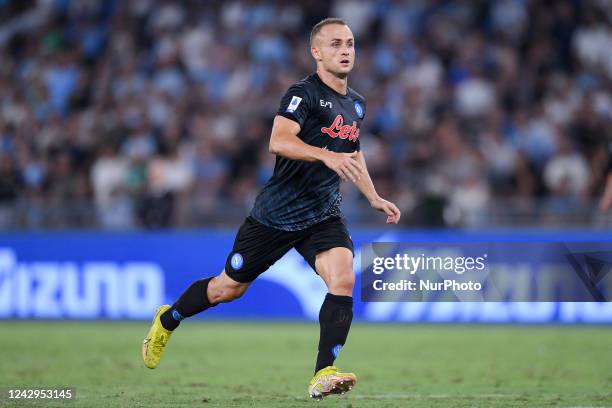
{"left": 142, "top": 271, "right": 250, "bottom": 368}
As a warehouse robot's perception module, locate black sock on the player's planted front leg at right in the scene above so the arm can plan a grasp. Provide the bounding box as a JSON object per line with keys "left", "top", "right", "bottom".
{"left": 315, "top": 293, "right": 353, "bottom": 373}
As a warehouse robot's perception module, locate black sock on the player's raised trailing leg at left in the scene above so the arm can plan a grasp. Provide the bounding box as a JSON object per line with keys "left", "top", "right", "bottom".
{"left": 160, "top": 278, "right": 217, "bottom": 330}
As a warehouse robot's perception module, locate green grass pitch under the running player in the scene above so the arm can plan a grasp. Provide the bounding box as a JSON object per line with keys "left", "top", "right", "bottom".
{"left": 0, "top": 321, "right": 612, "bottom": 408}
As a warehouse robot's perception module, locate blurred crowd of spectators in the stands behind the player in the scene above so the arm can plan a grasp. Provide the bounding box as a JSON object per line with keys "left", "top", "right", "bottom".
{"left": 0, "top": 0, "right": 612, "bottom": 229}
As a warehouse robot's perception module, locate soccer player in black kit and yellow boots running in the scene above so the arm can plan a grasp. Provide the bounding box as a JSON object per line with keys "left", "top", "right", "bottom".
{"left": 142, "top": 18, "right": 401, "bottom": 398}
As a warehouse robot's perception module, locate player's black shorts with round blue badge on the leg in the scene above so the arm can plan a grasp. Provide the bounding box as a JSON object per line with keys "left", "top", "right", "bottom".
{"left": 225, "top": 217, "right": 355, "bottom": 283}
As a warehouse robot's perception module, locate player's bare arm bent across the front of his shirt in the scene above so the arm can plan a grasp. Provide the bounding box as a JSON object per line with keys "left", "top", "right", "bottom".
{"left": 268, "top": 115, "right": 364, "bottom": 182}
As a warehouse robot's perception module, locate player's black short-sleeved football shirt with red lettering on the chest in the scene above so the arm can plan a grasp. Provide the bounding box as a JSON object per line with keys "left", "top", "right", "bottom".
{"left": 251, "top": 74, "right": 366, "bottom": 231}
